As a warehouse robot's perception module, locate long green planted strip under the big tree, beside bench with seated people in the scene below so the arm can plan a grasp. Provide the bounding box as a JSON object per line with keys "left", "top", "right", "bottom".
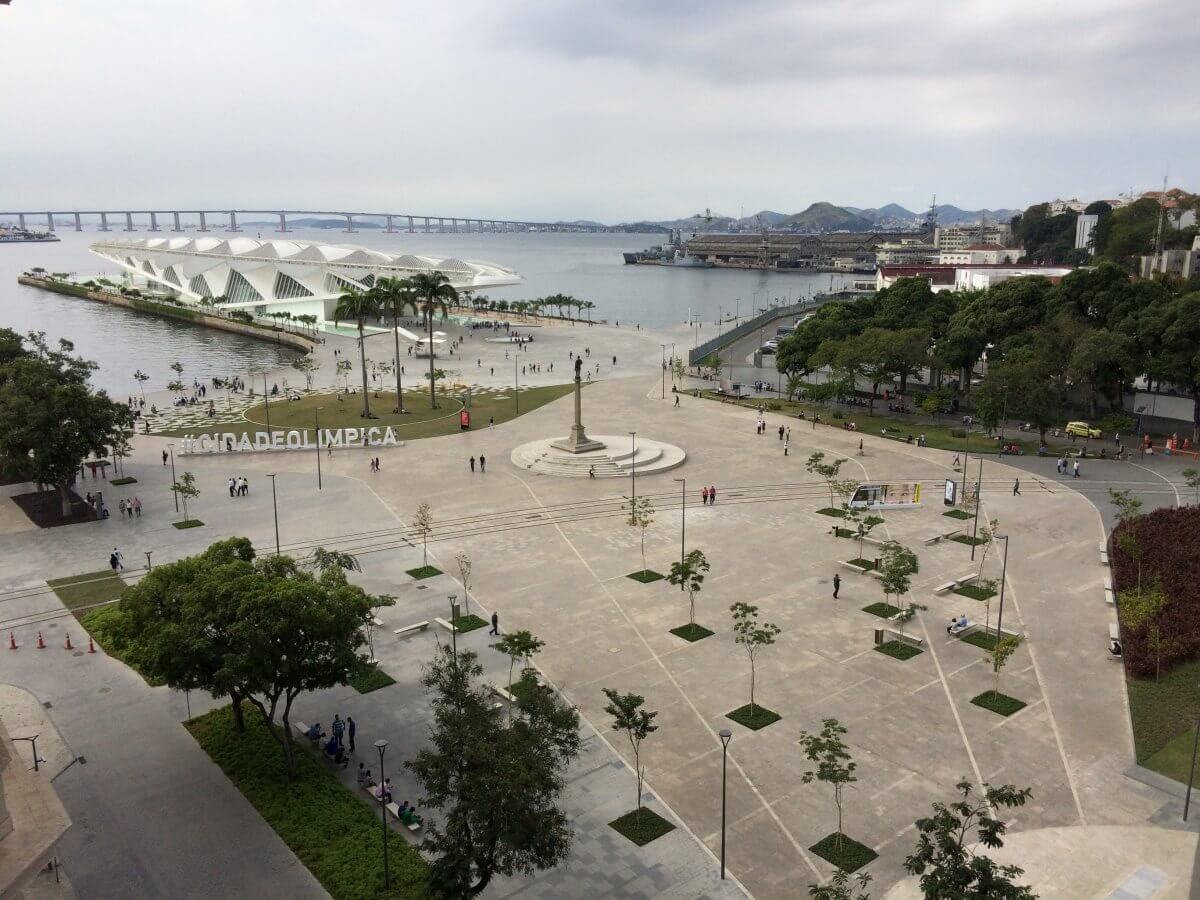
{"left": 187, "top": 707, "right": 430, "bottom": 898}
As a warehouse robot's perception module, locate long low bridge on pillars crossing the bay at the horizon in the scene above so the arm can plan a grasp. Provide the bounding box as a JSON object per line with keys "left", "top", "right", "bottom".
{"left": 0, "top": 209, "right": 607, "bottom": 234}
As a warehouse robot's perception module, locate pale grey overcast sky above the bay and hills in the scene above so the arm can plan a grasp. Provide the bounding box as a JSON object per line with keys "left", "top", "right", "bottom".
{"left": 0, "top": 0, "right": 1200, "bottom": 222}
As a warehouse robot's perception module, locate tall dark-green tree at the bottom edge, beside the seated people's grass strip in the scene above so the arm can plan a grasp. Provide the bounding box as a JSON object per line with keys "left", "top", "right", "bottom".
{"left": 404, "top": 647, "right": 580, "bottom": 898}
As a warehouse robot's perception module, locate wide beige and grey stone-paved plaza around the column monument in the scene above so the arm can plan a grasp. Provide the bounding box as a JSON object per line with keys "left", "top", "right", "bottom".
{"left": 0, "top": 326, "right": 1195, "bottom": 898}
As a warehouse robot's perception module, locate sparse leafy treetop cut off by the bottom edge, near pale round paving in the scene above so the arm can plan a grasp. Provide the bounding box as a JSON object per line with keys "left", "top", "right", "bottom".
{"left": 904, "top": 781, "right": 1037, "bottom": 900}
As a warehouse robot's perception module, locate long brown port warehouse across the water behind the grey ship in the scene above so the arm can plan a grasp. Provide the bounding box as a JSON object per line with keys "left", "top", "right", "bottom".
{"left": 688, "top": 232, "right": 914, "bottom": 271}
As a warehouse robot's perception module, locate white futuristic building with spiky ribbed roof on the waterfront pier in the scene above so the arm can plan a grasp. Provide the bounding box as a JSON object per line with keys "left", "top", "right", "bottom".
{"left": 91, "top": 238, "right": 521, "bottom": 322}
